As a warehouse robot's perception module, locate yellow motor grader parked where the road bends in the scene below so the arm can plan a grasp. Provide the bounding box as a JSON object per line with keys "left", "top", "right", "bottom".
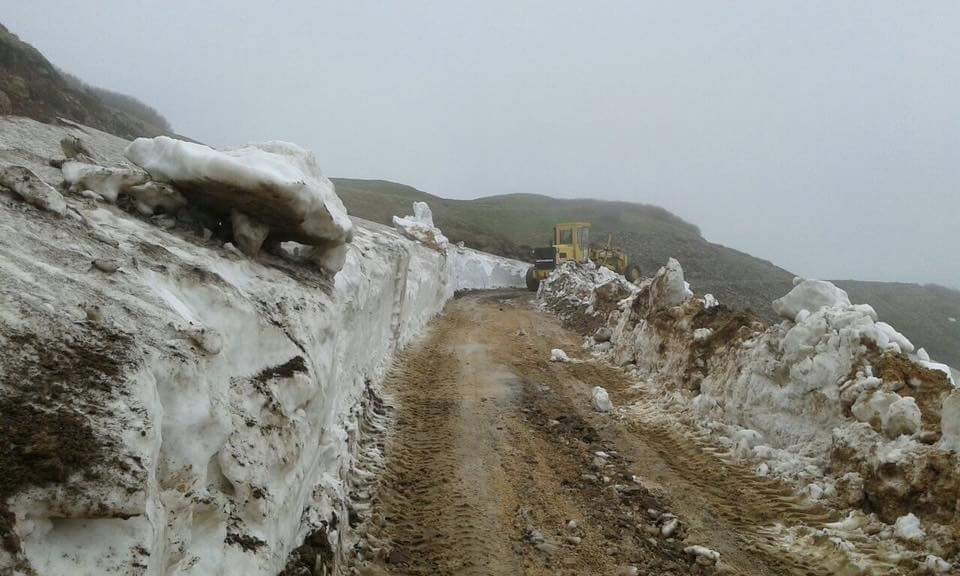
{"left": 527, "top": 222, "right": 640, "bottom": 290}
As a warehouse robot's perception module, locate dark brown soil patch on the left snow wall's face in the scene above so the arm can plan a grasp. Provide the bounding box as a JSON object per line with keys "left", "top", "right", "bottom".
{"left": 0, "top": 325, "right": 131, "bottom": 553}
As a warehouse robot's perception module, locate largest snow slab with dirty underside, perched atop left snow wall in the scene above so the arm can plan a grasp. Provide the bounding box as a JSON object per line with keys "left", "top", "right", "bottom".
{"left": 124, "top": 136, "right": 353, "bottom": 245}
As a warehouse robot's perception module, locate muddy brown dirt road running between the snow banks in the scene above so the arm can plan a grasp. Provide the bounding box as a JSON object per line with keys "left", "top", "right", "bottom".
{"left": 355, "top": 292, "right": 838, "bottom": 575}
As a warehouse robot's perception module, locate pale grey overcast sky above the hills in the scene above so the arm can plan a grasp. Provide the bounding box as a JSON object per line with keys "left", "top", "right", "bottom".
{"left": 7, "top": 0, "right": 960, "bottom": 287}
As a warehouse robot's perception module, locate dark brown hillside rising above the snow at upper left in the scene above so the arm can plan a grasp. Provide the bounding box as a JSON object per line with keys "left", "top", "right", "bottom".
{"left": 0, "top": 25, "right": 170, "bottom": 138}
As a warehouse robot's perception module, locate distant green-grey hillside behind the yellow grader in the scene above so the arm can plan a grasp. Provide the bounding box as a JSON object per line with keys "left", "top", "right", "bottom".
{"left": 334, "top": 178, "right": 960, "bottom": 366}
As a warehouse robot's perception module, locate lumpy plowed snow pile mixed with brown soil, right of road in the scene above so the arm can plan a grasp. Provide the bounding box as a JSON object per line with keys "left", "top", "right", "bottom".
{"left": 540, "top": 259, "right": 960, "bottom": 573}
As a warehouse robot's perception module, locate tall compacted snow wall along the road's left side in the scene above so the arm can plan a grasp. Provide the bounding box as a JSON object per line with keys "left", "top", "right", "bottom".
{"left": 0, "top": 119, "right": 527, "bottom": 575}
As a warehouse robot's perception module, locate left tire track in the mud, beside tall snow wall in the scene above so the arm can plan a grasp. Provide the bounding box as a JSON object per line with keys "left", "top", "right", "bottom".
{"left": 352, "top": 313, "right": 507, "bottom": 575}
